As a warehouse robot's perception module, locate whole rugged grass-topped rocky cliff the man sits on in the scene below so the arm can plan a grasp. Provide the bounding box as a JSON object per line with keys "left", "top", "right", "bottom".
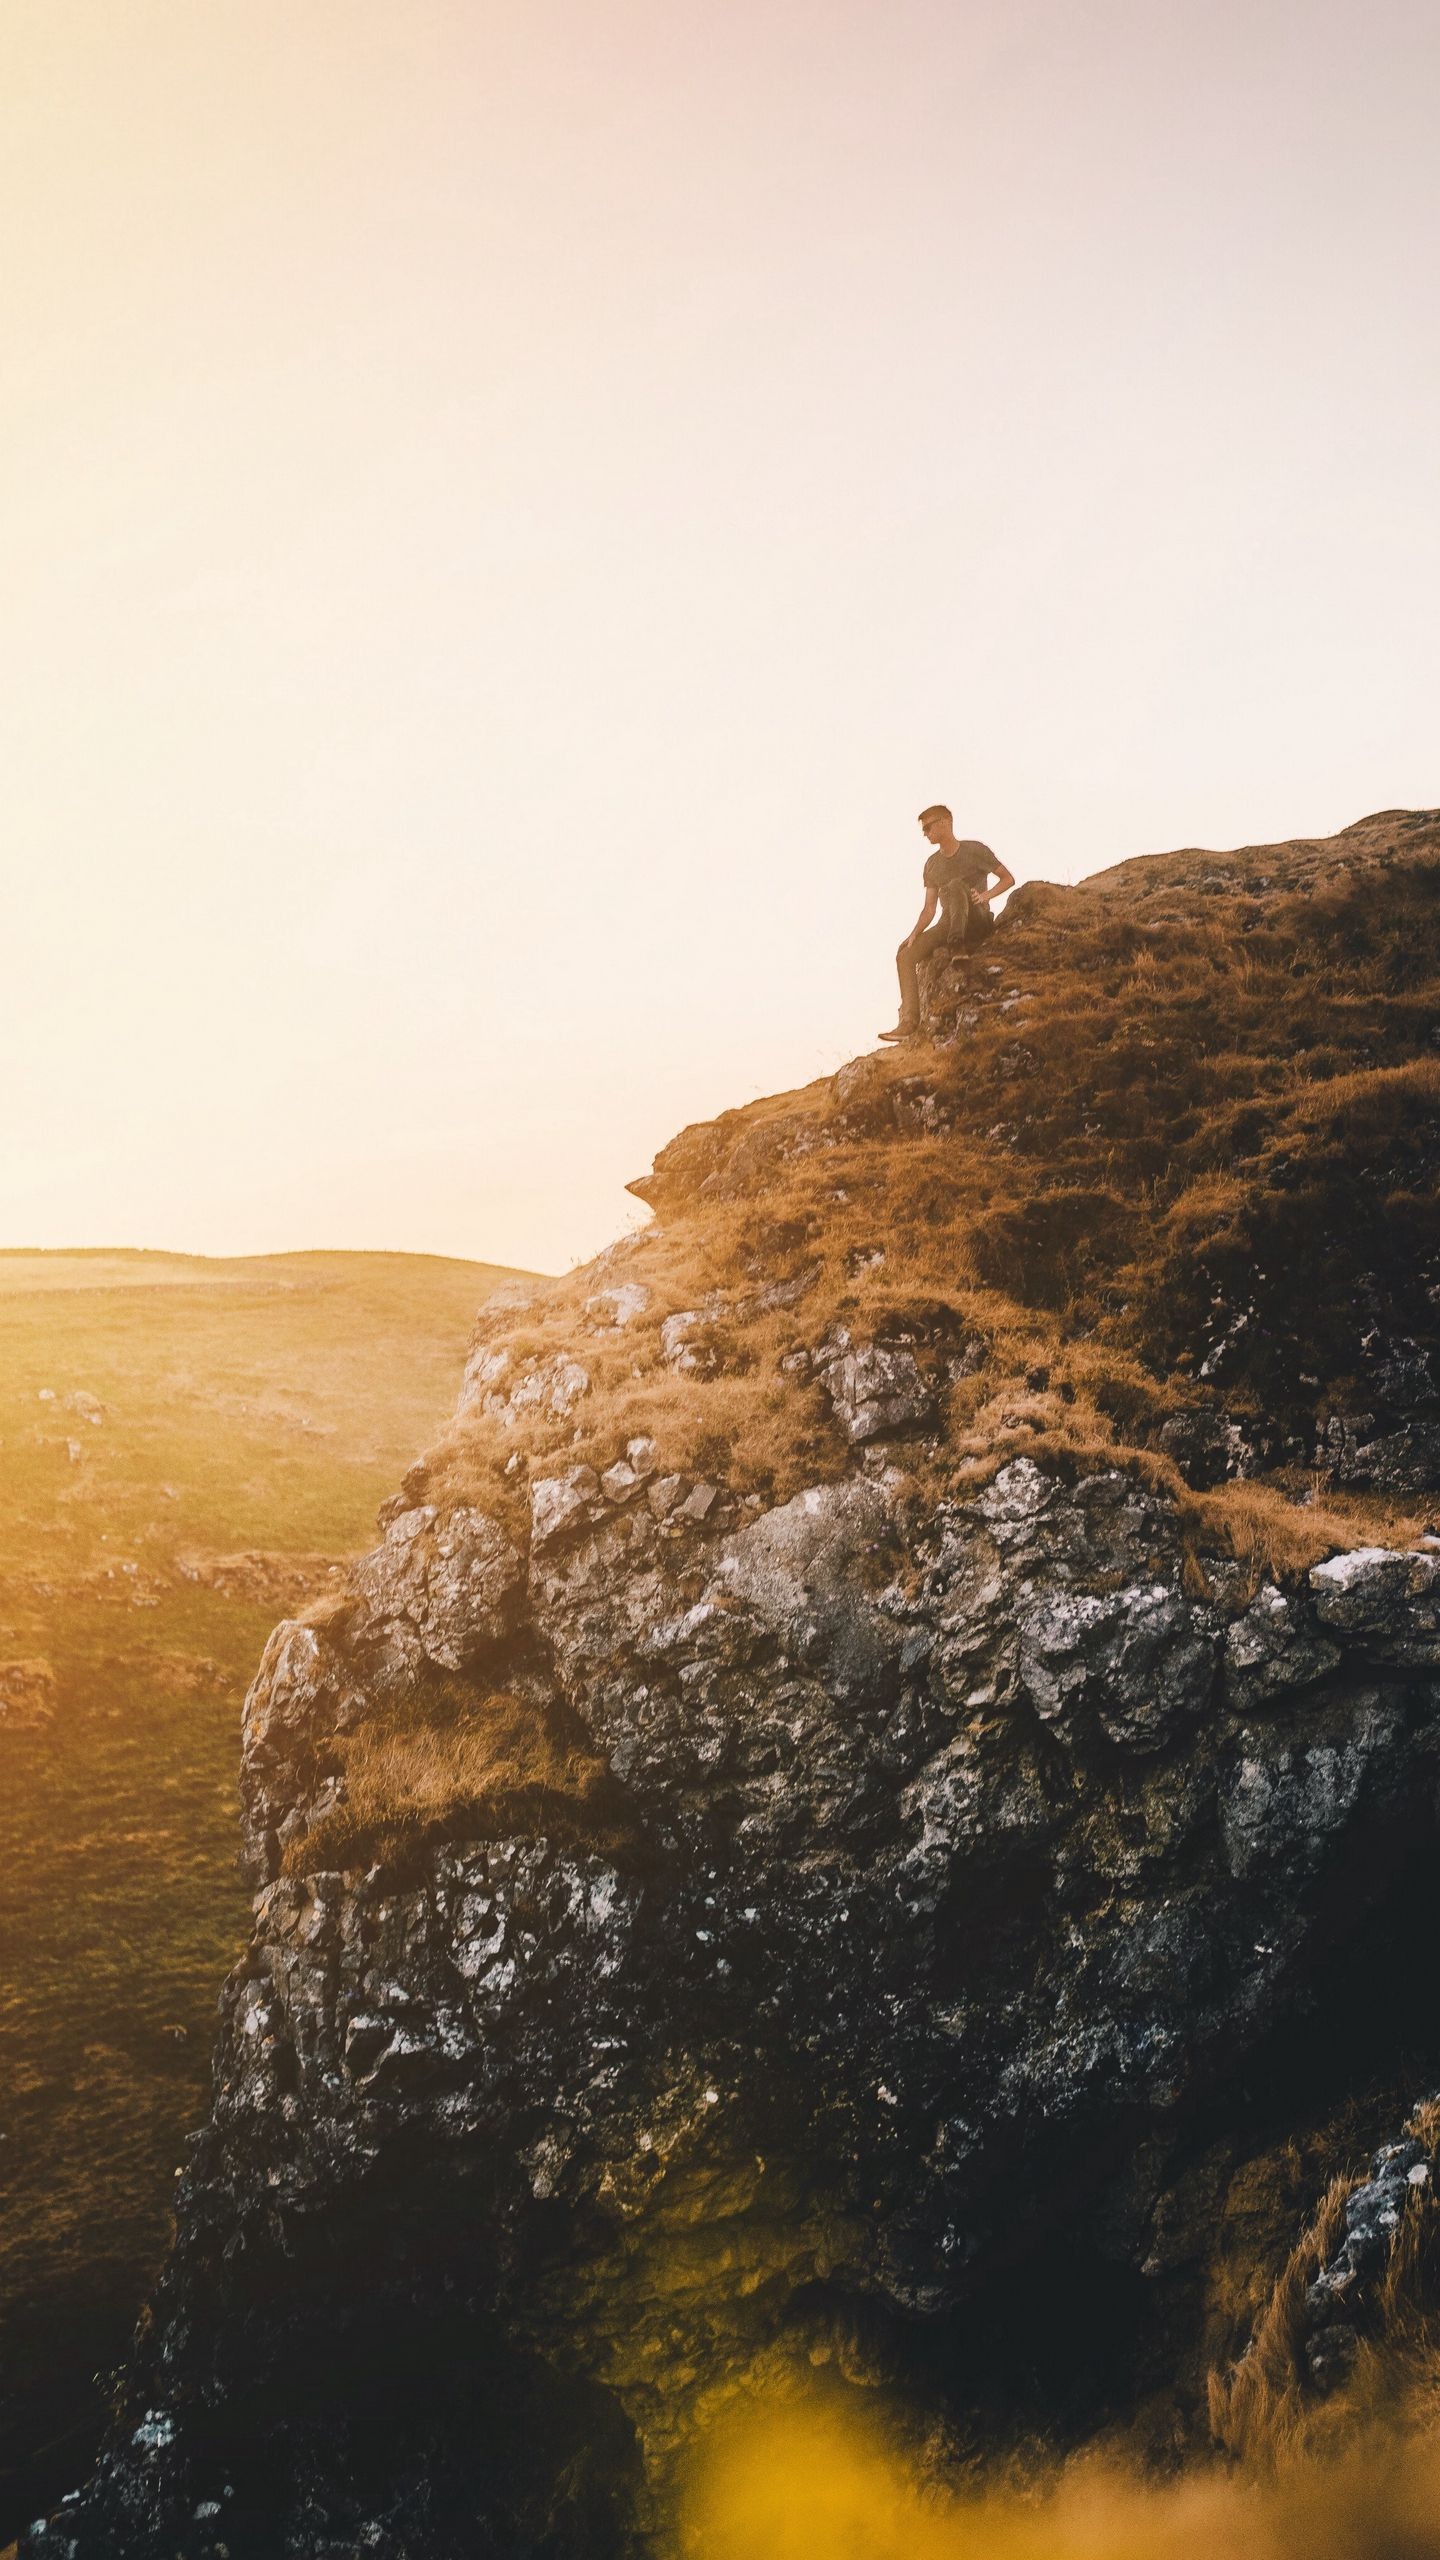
{"left": 36, "top": 812, "right": 1440, "bottom": 2560}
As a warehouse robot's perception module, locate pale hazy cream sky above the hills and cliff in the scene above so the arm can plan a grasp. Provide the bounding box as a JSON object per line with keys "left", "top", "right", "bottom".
{"left": 0, "top": 0, "right": 1440, "bottom": 1270}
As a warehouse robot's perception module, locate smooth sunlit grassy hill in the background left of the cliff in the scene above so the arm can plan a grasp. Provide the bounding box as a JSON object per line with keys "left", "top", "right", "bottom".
{"left": 0, "top": 1252, "right": 532, "bottom": 2540}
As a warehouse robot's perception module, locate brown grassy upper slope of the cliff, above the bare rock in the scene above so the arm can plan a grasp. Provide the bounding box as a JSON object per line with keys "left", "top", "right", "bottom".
{"left": 430, "top": 812, "right": 1440, "bottom": 1567}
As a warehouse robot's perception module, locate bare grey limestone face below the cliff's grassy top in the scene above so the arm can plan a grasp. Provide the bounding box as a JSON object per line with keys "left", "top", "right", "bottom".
{"left": 44, "top": 1459, "right": 1440, "bottom": 2555}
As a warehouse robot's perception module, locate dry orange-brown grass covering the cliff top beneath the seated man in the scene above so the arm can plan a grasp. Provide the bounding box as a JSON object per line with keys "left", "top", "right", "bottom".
{"left": 407, "top": 839, "right": 1440, "bottom": 1572}
